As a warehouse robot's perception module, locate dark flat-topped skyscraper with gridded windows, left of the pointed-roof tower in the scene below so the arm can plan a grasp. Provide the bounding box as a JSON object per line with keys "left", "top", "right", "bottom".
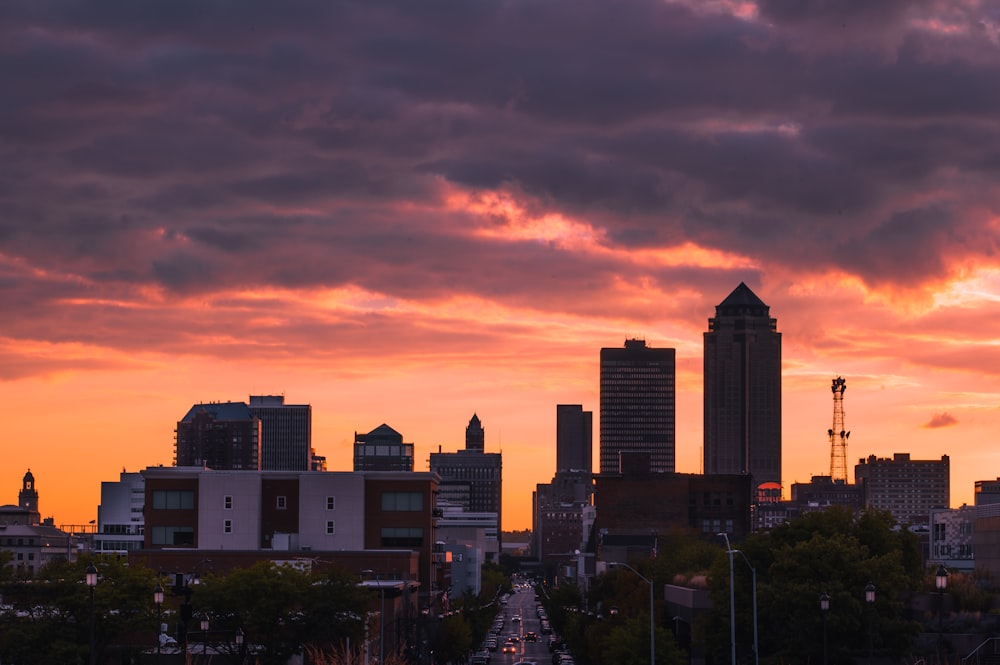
{"left": 600, "top": 339, "right": 676, "bottom": 473}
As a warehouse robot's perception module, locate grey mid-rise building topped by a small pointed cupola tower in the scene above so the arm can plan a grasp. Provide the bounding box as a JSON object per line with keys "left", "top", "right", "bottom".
{"left": 430, "top": 414, "right": 503, "bottom": 558}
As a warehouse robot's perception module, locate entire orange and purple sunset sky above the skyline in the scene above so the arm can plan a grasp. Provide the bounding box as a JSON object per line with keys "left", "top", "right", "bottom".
{"left": 0, "top": 0, "right": 1000, "bottom": 530}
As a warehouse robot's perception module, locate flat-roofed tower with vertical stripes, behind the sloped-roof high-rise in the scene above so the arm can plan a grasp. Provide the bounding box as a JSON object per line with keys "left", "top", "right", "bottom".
{"left": 250, "top": 395, "right": 312, "bottom": 471}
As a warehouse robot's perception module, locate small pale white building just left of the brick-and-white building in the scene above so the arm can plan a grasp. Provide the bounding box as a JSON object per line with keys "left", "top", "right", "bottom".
{"left": 94, "top": 470, "right": 146, "bottom": 555}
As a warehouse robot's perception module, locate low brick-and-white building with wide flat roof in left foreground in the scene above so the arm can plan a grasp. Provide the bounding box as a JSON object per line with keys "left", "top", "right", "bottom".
{"left": 139, "top": 467, "right": 442, "bottom": 605}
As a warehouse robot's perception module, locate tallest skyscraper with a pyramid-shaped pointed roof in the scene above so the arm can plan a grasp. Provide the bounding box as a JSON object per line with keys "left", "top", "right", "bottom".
{"left": 704, "top": 282, "right": 781, "bottom": 488}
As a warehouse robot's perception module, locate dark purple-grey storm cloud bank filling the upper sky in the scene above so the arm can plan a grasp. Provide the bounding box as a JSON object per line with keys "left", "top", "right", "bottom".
{"left": 0, "top": 0, "right": 1000, "bottom": 330}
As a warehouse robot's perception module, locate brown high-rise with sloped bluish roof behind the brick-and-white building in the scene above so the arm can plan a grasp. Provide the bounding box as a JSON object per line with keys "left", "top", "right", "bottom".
{"left": 174, "top": 402, "right": 261, "bottom": 471}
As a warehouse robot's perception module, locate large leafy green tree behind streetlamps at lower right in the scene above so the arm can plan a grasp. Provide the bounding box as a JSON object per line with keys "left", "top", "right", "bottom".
{"left": 703, "top": 508, "right": 923, "bottom": 663}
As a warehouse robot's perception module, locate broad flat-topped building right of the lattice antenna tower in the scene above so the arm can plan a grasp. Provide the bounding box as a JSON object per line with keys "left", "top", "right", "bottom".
{"left": 854, "top": 453, "right": 951, "bottom": 525}
